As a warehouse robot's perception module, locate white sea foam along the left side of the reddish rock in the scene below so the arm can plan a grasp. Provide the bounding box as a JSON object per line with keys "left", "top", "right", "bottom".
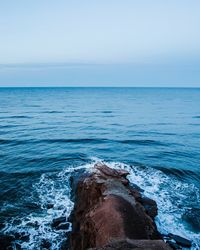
{"left": 3, "top": 162, "right": 94, "bottom": 250}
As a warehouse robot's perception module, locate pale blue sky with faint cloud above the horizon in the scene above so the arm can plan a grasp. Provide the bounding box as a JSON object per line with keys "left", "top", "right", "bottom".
{"left": 0, "top": 0, "right": 200, "bottom": 87}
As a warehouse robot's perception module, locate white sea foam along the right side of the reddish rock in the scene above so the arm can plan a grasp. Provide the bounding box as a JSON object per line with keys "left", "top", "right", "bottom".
{"left": 100, "top": 162, "right": 200, "bottom": 250}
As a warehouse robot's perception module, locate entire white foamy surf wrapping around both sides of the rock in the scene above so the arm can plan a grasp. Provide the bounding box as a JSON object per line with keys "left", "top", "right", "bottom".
{"left": 3, "top": 158, "right": 200, "bottom": 250}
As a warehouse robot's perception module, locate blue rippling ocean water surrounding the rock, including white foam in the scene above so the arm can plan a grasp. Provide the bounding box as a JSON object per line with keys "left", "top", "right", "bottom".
{"left": 0, "top": 88, "right": 200, "bottom": 250}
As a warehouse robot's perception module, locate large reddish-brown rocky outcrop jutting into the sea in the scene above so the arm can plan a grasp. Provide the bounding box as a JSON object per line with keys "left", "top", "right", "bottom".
{"left": 70, "top": 164, "right": 171, "bottom": 250}
